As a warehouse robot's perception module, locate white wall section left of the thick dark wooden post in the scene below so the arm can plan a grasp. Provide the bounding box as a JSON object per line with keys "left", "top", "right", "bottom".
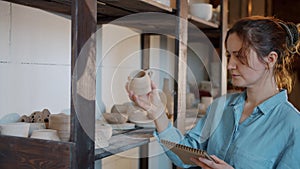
{"left": 0, "top": 1, "right": 71, "bottom": 115}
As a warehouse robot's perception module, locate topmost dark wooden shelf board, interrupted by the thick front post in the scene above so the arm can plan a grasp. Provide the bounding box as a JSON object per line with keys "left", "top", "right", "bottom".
{"left": 4, "top": 0, "right": 174, "bottom": 24}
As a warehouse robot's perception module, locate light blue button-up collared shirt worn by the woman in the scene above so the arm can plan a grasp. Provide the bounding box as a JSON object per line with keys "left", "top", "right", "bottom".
{"left": 154, "top": 90, "right": 300, "bottom": 169}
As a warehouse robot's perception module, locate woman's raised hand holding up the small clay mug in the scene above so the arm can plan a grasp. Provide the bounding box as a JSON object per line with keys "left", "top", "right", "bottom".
{"left": 126, "top": 81, "right": 166, "bottom": 120}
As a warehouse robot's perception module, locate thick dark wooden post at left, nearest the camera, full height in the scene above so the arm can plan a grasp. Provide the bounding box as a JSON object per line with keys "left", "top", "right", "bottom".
{"left": 71, "top": 0, "right": 97, "bottom": 169}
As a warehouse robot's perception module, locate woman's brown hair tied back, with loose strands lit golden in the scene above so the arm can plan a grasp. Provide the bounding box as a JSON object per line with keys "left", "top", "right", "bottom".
{"left": 225, "top": 16, "right": 300, "bottom": 92}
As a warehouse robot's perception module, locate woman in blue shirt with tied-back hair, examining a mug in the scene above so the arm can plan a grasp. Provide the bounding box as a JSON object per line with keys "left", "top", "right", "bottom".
{"left": 129, "top": 16, "right": 300, "bottom": 169}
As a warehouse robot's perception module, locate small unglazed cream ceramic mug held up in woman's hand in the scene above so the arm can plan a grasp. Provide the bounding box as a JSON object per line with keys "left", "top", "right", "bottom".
{"left": 128, "top": 70, "right": 153, "bottom": 95}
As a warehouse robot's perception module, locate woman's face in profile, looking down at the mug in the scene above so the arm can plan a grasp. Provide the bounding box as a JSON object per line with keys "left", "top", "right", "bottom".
{"left": 226, "top": 33, "right": 268, "bottom": 88}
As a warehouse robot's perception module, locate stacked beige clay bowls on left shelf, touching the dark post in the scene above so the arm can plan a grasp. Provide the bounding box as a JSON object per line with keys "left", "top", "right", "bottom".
{"left": 49, "top": 113, "right": 70, "bottom": 141}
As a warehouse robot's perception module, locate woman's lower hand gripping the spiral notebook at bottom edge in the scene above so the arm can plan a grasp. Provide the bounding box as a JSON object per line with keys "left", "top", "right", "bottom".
{"left": 191, "top": 155, "right": 233, "bottom": 169}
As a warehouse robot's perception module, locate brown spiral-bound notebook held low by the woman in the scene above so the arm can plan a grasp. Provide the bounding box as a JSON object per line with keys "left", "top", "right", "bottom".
{"left": 160, "top": 139, "right": 215, "bottom": 165}
